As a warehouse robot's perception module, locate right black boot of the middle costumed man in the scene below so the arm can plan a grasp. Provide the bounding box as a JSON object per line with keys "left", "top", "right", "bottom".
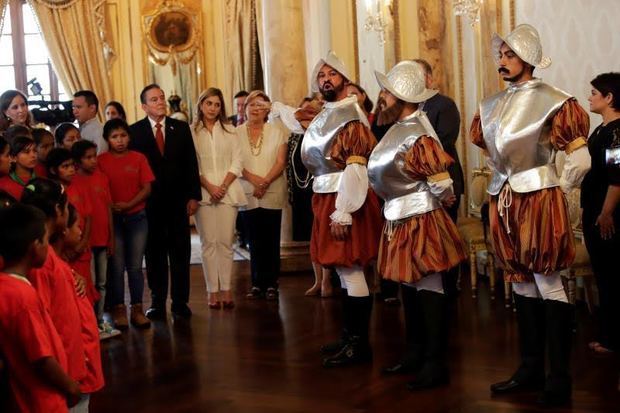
{"left": 407, "top": 290, "right": 449, "bottom": 390}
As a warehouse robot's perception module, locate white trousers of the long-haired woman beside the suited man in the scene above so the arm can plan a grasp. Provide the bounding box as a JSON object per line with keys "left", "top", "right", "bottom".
{"left": 194, "top": 204, "right": 237, "bottom": 293}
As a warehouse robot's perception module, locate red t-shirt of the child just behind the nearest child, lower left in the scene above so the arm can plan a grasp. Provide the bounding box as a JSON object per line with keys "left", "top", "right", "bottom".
{"left": 28, "top": 246, "right": 86, "bottom": 382}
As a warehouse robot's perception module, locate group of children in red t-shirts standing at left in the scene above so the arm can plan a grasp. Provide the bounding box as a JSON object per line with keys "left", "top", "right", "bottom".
{"left": 0, "top": 119, "right": 154, "bottom": 412}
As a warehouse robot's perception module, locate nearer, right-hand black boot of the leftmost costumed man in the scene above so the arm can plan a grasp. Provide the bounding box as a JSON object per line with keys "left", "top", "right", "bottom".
{"left": 323, "top": 296, "right": 373, "bottom": 367}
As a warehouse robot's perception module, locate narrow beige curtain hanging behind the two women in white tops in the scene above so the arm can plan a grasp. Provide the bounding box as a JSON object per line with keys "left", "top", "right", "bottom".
{"left": 224, "top": 0, "right": 262, "bottom": 99}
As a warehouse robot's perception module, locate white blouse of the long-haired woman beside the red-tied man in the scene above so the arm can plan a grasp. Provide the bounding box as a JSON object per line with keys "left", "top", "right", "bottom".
{"left": 192, "top": 122, "right": 247, "bottom": 206}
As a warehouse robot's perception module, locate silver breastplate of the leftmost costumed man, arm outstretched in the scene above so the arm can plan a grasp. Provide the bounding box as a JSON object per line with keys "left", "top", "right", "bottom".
{"left": 301, "top": 96, "right": 368, "bottom": 193}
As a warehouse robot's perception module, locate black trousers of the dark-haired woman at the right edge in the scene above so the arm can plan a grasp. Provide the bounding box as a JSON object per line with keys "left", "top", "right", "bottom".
{"left": 583, "top": 208, "right": 620, "bottom": 351}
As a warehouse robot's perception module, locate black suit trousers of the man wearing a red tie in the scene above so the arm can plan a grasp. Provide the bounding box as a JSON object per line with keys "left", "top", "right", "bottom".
{"left": 146, "top": 204, "right": 191, "bottom": 308}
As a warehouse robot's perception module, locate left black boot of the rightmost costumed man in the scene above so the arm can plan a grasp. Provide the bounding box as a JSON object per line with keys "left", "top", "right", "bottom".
{"left": 491, "top": 294, "right": 545, "bottom": 394}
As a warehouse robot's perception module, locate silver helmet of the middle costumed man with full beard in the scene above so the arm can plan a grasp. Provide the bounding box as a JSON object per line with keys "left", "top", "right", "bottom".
{"left": 375, "top": 60, "right": 438, "bottom": 103}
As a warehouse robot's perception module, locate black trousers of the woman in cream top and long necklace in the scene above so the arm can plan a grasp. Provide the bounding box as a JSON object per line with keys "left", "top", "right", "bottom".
{"left": 243, "top": 208, "right": 282, "bottom": 290}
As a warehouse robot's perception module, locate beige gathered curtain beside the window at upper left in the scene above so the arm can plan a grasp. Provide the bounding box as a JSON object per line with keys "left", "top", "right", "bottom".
{"left": 28, "top": 0, "right": 112, "bottom": 114}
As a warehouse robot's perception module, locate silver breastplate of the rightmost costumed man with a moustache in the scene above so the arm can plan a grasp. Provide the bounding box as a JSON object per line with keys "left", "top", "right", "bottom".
{"left": 480, "top": 79, "right": 571, "bottom": 195}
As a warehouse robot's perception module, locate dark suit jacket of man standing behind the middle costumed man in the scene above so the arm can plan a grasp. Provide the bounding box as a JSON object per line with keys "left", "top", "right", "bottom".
{"left": 422, "top": 93, "right": 464, "bottom": 196}
